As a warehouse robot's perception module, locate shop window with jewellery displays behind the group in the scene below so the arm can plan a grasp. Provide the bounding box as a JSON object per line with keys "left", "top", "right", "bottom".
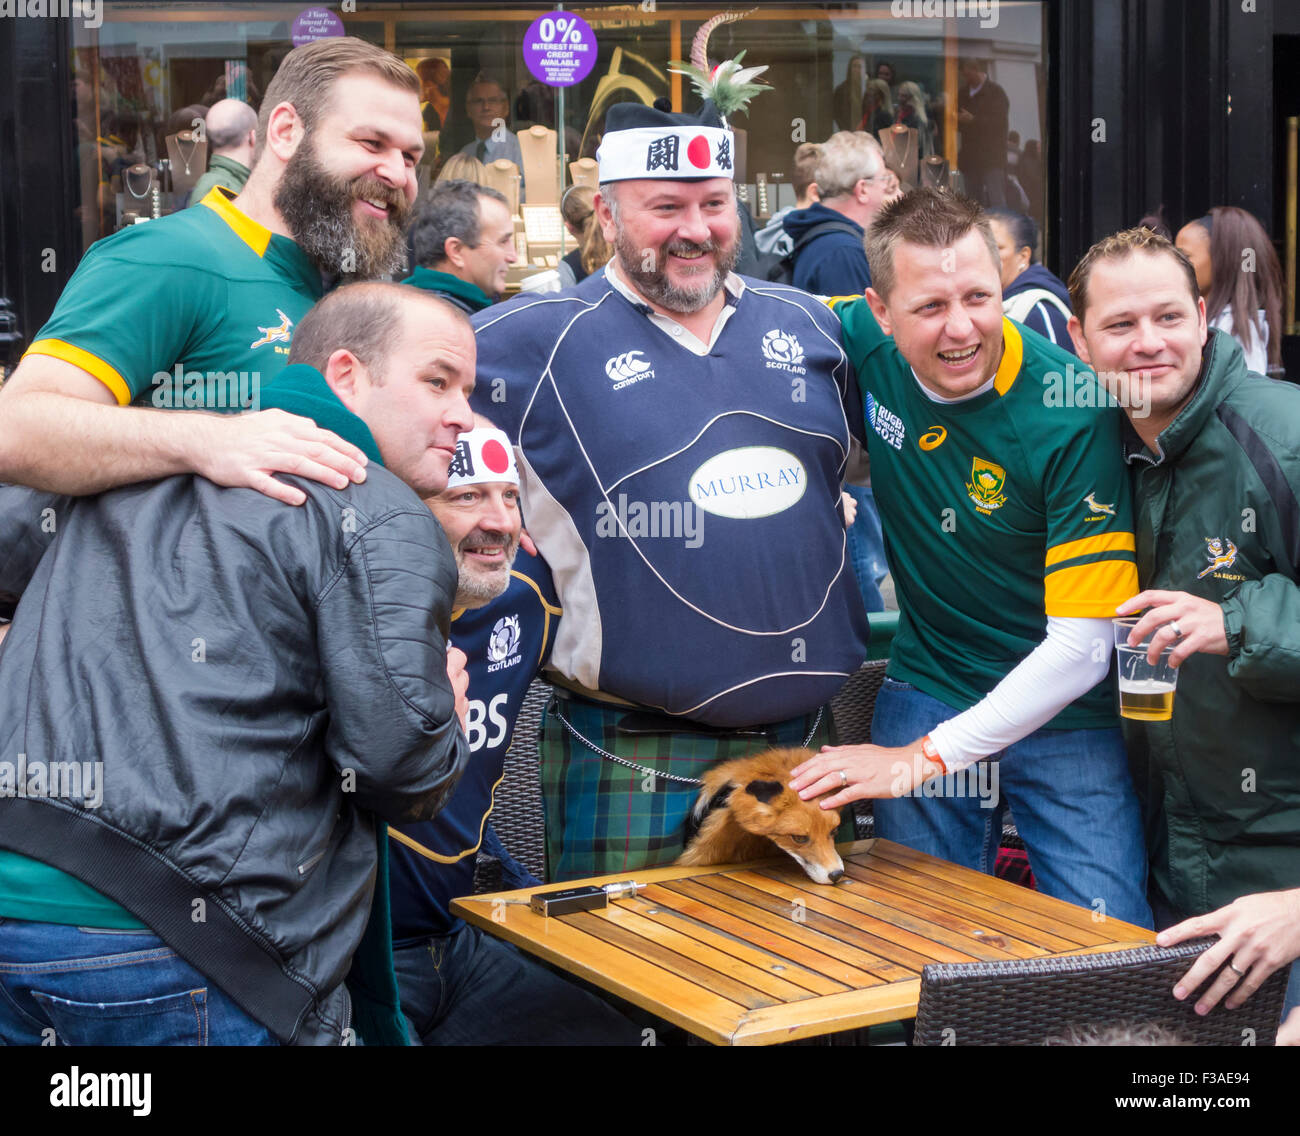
{"left": 72, "top": 0, "right": 1048, "bottom": 261}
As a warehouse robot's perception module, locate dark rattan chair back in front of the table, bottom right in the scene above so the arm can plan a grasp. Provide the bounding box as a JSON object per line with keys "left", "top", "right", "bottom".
{"left": 913, "top": 938, "right": 1290, "bottom": 1045}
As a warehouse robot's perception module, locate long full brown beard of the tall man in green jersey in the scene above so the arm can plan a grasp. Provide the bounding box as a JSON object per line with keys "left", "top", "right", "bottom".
{"left": 273, "top": 136, "right": 411, "bottom": 279}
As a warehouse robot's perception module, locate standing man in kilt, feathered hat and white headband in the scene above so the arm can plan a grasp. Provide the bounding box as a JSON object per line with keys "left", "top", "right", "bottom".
{"left": 473, "top": 27, "right": 867, "bottom": 880}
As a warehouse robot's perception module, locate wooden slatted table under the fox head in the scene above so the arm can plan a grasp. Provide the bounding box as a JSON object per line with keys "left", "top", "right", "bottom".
{"left": 451, "top": 840, "right": 1154, "bottom": 1045}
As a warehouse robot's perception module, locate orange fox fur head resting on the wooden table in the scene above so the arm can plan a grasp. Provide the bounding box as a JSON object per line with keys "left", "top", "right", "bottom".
{"left": 677, "top": 749, "right": 844, "bottom": 884}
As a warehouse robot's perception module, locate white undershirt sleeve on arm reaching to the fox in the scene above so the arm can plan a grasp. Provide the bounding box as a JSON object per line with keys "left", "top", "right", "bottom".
{"left": 930, "top": 615, "right": 1115, "bottom": 773}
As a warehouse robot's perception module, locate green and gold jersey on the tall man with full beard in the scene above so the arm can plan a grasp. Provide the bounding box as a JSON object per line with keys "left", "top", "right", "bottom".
{"left": 27, "top": 187, "right": 322, "bottom": 411}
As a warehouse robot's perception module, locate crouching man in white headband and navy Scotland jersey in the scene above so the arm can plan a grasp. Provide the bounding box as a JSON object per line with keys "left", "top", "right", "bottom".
{"left": 389, "top": 415, "right": 641, "bottom": 1045}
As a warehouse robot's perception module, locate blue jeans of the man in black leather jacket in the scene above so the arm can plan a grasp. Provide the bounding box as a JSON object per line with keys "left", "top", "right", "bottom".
{"left": 0, "top": 918, "right": 280, "bottom": 1045}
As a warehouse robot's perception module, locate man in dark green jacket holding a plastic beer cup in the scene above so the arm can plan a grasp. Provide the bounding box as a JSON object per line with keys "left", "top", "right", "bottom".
{"left": 1070, "top": 229, "right": 1300, "bottom": 1009}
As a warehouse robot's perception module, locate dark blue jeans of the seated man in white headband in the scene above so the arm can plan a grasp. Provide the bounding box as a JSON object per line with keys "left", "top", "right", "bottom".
{"left": 393, "top": 923, "right": 641, "bottom": 1045}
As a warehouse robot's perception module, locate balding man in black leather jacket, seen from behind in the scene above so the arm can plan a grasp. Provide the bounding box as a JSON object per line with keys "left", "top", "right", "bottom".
{"left": 0, "top": 285, "right": 475, "bottom": 1044}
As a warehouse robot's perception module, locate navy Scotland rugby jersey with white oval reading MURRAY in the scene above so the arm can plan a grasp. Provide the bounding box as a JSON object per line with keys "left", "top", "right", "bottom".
{"left": 473, "top": 272, "right": 867, "bottom": 727}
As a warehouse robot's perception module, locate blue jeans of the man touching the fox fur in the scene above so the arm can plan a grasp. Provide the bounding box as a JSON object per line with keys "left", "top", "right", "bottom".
{"left": 871, "top": 678, "right": 1153, "bottom": 928}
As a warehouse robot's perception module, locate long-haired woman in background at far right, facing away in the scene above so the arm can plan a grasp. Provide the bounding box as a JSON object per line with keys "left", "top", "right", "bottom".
{"left": 1174, "top": 205, "right": 1282, "bottom": 374}
